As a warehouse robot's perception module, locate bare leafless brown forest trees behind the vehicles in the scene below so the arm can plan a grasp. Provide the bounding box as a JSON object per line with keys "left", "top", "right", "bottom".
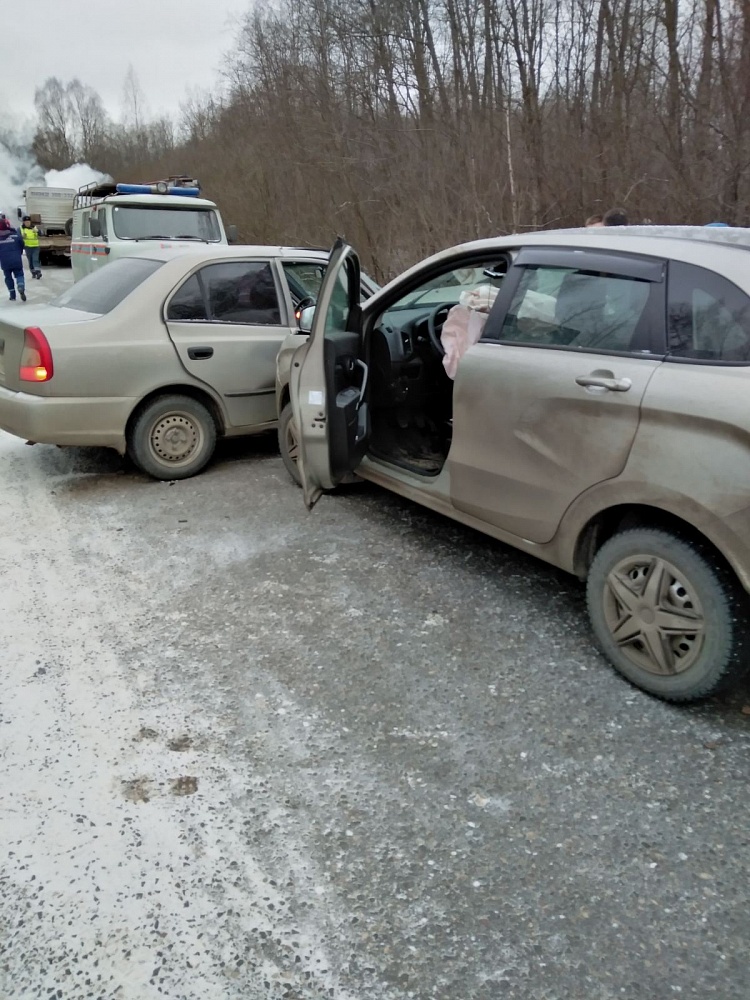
{"left": 26, "top": 0, "right": 750, "bottom": 278}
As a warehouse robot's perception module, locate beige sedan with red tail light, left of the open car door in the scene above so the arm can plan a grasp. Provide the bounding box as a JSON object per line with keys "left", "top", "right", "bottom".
{"left": 0, "top": 247, "right": 372, "bottom": 480}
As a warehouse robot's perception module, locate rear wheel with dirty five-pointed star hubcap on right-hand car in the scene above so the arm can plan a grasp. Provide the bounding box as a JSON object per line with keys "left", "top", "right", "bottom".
{"left": 587, "top": 528, "right": 745, "bottom": 701}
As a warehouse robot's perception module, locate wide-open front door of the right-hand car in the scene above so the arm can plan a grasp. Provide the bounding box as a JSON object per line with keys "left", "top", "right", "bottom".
{"left": 290, "top": 240, "right": 370, "bottom": 508}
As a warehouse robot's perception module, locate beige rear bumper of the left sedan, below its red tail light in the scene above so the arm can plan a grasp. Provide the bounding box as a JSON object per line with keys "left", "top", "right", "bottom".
{"left": 0, "top": 386, "right": 131, "bottom": 454}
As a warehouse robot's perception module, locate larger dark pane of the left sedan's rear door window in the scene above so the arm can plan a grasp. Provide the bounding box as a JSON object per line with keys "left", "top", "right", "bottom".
{"left": 201, "top": 261, "right": 281, "bottom": 326}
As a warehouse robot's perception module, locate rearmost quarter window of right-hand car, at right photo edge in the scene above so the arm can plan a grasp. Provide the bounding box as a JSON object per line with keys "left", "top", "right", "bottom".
{"left": 668, "top": 261, "right": 750, "bottom": 364}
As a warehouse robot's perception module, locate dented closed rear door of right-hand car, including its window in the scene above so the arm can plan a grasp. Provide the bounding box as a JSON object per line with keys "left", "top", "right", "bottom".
{"left": 448, "top": 250, "right": 665, "bottom": 543}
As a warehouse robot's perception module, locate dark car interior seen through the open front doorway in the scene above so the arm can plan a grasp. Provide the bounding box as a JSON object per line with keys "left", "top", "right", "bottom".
{"left": 369, "top": 255, "right": 511, "bottom": 476}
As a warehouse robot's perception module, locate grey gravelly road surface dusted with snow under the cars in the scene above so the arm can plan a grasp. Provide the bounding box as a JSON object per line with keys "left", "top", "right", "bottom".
{"left": 0, "top": 260, "right": 750, "bottom": 1000}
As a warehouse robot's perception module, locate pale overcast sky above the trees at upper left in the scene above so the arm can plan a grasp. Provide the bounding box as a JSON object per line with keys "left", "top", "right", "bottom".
{"left": 0, "top": 0, "right": 252, "bottom": 131}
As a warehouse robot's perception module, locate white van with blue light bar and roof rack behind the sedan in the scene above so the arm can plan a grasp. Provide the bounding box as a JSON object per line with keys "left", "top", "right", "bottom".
{"left": 71, "top": 176, "right": 237, "bottom": 281}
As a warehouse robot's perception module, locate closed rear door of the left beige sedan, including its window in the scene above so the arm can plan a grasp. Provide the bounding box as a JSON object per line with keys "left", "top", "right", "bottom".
{"left": 165, "top": 258, "right": 289, "bottom": 428}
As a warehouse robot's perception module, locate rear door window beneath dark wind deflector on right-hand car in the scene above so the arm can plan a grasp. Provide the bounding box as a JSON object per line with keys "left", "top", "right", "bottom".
{"left": 490, "top": 267, "right": 650, "bottom": 351}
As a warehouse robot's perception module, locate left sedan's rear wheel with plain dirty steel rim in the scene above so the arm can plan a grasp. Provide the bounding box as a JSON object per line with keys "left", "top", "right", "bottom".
{"left": 128, "top": 395, "right": 216, "bottom": 480}
